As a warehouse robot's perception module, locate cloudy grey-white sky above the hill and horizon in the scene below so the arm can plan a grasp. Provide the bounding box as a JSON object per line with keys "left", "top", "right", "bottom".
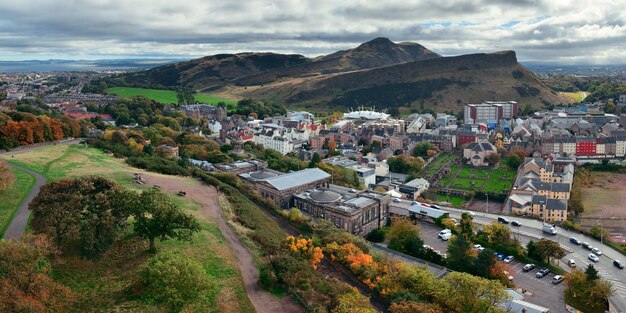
{"left": 0, "top": 0, "right": 626, "bottom": 64}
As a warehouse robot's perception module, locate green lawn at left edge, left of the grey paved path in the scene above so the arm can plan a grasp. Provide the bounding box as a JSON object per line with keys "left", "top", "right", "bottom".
{"left": 0, "top": 168, "right": 35, "bottom": 238}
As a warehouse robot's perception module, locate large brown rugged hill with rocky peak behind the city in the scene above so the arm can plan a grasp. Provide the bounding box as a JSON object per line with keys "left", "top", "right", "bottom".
{"left": 107, "top": 38, "right": 569, "bottom": 111}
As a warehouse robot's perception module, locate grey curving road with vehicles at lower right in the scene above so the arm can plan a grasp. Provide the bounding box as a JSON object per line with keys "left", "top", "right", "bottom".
{"left": 442, "top": 207, "right": 626, "bottom": 312}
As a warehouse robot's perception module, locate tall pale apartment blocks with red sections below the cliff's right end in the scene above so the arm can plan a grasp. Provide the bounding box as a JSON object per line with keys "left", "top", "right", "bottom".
{"left": 463, "top": 101, "right": 518, "bottom": 123}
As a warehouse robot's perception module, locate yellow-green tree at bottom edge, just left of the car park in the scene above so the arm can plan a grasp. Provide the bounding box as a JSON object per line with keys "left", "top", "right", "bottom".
{"left": 437, "top": 272, "right": 508, "bottom": 313}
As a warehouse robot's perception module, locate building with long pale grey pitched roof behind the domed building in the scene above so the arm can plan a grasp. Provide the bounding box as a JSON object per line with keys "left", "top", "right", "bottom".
{"left": 239, "top": 168, "right": 331, "bottom": 209}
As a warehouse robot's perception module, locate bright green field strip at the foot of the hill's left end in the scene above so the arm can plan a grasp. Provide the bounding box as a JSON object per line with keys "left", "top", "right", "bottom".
{"left": 106, "top": 87, "right": 237, "bottom": 104}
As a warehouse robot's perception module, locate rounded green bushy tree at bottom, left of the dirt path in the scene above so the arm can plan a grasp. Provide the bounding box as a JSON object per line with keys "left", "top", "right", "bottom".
{"left": 140, "top": 253, "right": 211, "bottom": 312}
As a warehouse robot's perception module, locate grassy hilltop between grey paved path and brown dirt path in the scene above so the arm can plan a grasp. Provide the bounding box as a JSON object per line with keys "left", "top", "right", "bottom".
{"left": 4, "top": 145, "right": 254, "bottom": 312}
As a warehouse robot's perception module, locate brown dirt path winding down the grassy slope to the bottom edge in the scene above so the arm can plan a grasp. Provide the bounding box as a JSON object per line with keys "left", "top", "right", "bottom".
{"left": 144, "top": 174, "right": 303, "bottom": 313}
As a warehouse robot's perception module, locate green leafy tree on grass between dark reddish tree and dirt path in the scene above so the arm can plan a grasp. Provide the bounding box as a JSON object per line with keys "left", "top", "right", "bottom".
{"left": 134, "top": 189, "right": 201, "bottom": 252}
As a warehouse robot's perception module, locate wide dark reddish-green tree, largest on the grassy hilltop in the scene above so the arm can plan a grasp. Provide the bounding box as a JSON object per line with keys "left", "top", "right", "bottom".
{"left": 29, "top": 176, "right": 134, "bottom": 257}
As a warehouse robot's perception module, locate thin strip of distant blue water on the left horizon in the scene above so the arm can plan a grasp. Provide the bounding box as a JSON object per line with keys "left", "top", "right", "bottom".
{"left": 0, "top": 60, "right": 185, "bottom": 73}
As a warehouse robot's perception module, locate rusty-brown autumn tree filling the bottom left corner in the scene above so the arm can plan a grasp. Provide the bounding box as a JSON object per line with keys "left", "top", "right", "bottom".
{"left": 0, "top": 234, "right": 74, "bottom": 313}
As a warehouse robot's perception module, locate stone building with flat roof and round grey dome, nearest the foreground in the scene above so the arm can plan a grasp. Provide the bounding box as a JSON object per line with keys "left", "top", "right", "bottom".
{"left": 293, "top": 183, "right": 391, "bottom": 235}
